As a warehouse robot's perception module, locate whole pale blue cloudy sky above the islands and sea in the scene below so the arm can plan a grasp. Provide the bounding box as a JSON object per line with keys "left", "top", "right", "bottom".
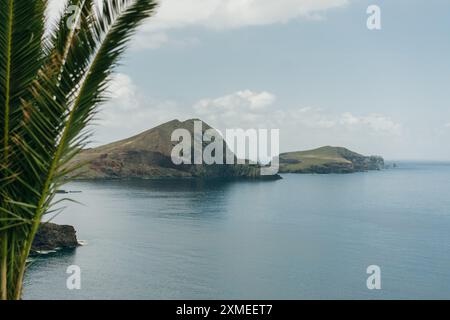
{"left": 50, "top": 0, "right": 450, "bottom": 160}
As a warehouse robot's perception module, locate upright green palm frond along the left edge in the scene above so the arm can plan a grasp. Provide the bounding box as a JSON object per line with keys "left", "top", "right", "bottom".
{"left": 0, "top": 0, "right": 47, "bottom": 299}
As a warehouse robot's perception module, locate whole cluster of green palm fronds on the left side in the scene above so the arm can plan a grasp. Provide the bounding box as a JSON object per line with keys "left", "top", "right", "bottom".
{"left": 0, "top": 0, "right": 157, "bottom": 299}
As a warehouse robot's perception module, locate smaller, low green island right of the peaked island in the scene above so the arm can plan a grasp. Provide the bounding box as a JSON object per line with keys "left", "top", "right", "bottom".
{"left": 280, "top": 146, "right": 384, "bottom": 174}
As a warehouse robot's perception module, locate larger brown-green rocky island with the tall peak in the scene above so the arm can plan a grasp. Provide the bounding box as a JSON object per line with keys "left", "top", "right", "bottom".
{"left": 67, "top": 119, "right": 278, "bottom": 179}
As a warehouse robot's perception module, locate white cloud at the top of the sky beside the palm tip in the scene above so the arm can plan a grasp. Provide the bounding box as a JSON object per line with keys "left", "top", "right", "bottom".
{"left": 49, "top": 0, "right": 350, "bottom": 49}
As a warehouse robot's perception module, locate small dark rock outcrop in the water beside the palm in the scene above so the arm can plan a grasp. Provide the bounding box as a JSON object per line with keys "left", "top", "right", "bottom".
{"left": 32, "top": 223, "right": 78, "bottom": 252}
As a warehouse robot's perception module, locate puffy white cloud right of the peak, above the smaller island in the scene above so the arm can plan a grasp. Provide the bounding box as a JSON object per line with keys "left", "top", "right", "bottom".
{"left": 194, "top": 90, "right": 402, "bottom": 136}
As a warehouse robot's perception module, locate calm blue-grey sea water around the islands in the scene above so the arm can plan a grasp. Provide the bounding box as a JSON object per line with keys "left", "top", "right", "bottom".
{"left": 25, "top": 162, "right": 450, "bottom": 299}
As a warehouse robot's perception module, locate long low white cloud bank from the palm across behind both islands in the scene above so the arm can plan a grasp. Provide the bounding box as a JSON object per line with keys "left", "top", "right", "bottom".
{"left": 100, "top": 73, "right": 404, "bottom": 137}
